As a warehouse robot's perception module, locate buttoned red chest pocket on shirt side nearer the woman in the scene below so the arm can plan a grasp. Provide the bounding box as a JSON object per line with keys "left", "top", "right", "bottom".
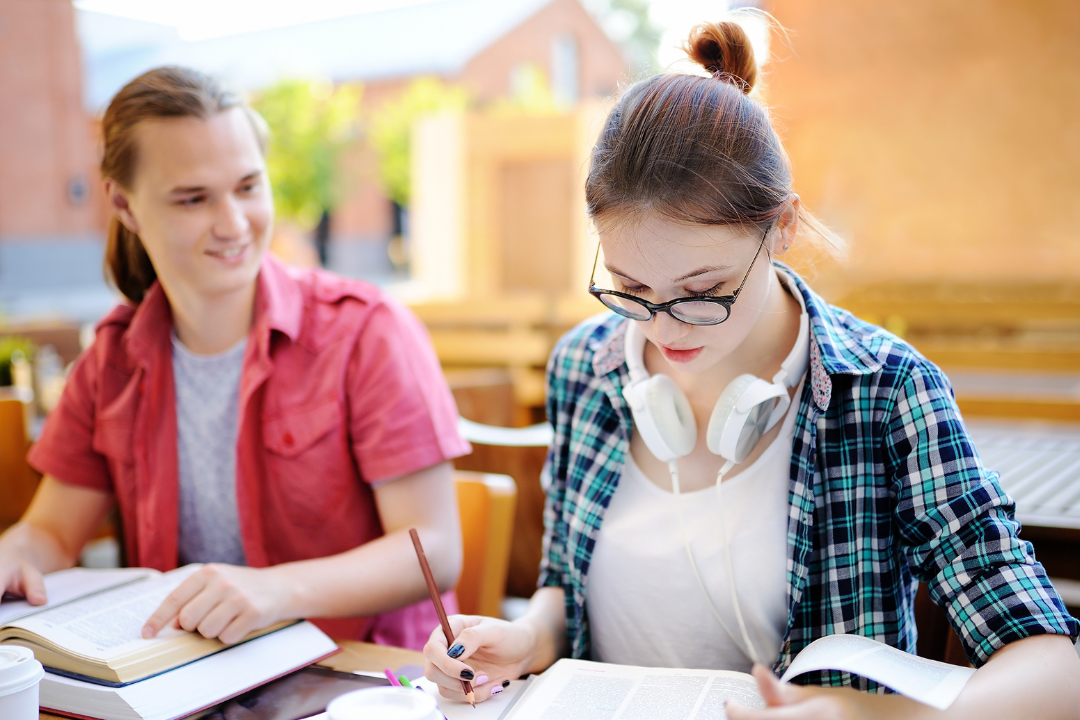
{"left": 262, "top": 399, "right": 360, "bottom": 526}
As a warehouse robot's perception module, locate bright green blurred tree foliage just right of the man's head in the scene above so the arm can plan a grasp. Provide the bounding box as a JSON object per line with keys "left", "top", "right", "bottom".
{"left": 252, "top": 80, "right": 361, "bottom": 228}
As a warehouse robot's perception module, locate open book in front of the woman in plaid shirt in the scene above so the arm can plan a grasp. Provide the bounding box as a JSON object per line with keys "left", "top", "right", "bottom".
{"left": 486, "top": 635, "right": 974, "bottom": 720}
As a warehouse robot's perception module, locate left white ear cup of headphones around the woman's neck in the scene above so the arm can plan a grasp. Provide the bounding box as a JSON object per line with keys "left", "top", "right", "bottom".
{"left": 623, "top": 375, "right": 698, "bottom": 462}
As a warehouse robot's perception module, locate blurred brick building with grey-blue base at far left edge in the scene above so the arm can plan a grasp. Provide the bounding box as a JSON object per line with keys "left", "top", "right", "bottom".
{"left": 0, "top": 0, "right": 111, "bottom": 317}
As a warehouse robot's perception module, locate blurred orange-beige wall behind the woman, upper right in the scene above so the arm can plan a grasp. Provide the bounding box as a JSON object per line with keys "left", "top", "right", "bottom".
{"left": 766, "top": 0, "right": 1080, "bottom": 293}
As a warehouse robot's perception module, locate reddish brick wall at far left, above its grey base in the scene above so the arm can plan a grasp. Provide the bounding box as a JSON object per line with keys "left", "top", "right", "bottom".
{"left": 0, "top": 0, "right": 102, "bottom": 240}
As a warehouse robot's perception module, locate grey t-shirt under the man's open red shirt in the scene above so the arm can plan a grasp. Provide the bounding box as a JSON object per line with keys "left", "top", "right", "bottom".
{"left": 173, "top": 335, "right": 247, "bottom": 565}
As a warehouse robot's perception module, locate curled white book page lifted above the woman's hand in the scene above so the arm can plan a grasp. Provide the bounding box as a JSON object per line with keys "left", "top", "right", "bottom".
{"left": 781, "top": 635, "right": 975, "bottom": 710}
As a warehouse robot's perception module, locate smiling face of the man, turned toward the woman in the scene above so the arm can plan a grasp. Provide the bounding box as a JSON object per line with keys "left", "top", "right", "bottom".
{"left": 108, "top": 108, "right": 273, "bottom": 300}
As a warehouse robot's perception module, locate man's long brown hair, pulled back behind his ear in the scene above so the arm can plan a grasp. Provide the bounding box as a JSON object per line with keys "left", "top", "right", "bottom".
{"left": 102, "top": 67, "right": 268, "bottom": 304}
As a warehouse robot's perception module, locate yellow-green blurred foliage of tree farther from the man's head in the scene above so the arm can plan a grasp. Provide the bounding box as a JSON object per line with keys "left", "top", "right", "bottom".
{"left": 368, "top": 78, "right": 469, "bottom": 207}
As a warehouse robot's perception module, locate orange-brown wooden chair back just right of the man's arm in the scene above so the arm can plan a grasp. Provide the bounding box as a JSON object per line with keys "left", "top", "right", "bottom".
{"left": 454, "top": 472, "right": 517, "bottom": 617}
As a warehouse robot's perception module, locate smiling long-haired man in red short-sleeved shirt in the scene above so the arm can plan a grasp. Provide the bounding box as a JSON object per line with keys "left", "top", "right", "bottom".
{"left": 0, "top": 68, "right": 468, "bottom": 648}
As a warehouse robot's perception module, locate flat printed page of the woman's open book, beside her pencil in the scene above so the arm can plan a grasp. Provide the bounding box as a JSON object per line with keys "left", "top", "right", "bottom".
{"left": 503, "top": 660, "right": 765, "bottom": 720}
